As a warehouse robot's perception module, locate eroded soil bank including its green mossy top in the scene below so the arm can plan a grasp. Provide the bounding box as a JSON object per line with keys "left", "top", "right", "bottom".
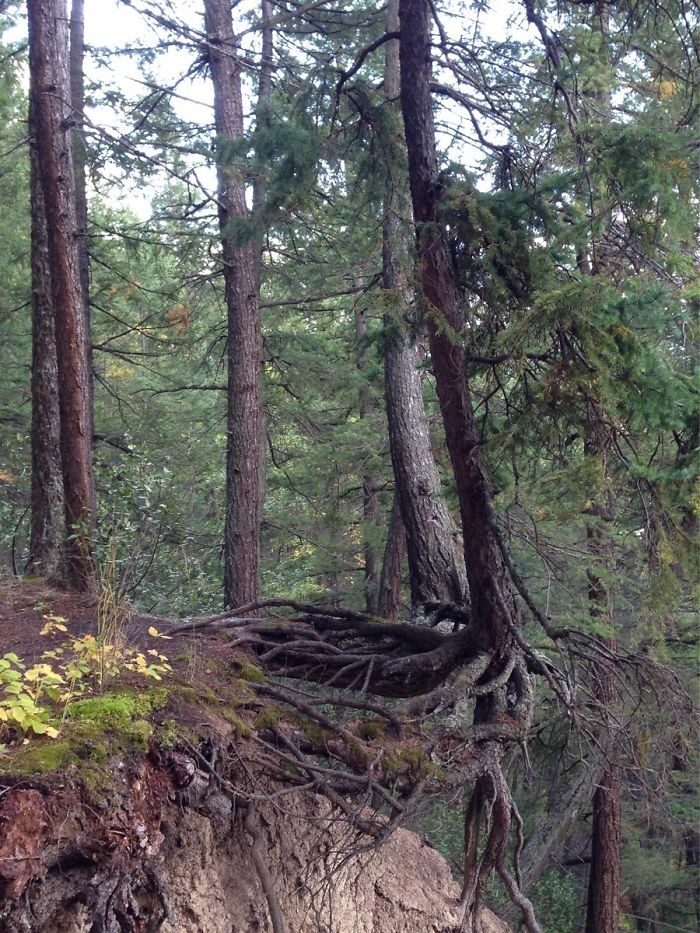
{"left": 0, "top": 585, "right": 508, "bottom": 933}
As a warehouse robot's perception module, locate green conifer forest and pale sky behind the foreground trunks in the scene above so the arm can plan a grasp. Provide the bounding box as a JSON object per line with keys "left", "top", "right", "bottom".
{"left": 0, "top": 0, "right": 700, "bottom": 931}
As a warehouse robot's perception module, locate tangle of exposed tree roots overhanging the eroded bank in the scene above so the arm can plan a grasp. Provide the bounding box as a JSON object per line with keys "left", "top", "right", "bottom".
{"left": 156, "top": 593, "right": 688, "bottom": 933}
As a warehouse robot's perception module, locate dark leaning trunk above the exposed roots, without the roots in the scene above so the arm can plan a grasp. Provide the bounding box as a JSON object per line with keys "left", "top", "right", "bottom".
{"left": 400, "top": 0, "right": 517, "bottom": 651}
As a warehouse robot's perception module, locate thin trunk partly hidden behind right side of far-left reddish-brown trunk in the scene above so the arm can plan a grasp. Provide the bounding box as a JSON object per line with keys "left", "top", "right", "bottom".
{"left": 70, "top": 0, "right": 97, "bottom": 533}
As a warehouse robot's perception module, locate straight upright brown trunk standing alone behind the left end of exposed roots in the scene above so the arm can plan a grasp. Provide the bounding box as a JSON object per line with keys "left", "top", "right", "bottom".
{"left": 204, "top": 0, "right": 263, "bottom": 607}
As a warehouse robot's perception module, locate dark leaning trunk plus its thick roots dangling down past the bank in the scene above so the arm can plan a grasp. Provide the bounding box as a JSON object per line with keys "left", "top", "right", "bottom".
{"left": 399, "top": 0, "right": 540, "bottom": 933}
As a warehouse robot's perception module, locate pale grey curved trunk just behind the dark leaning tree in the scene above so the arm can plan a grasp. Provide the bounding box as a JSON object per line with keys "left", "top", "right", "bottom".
{"left": 382, "top": 0, "right": 467, "bottom": 604}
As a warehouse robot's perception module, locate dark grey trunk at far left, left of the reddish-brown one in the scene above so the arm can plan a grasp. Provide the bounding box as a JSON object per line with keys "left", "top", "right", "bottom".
{"left": 27, "top": 93, "right": 64, "bottom": 579}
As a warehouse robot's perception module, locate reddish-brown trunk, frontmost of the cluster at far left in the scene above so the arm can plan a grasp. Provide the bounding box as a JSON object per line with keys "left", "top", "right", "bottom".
{"left": 27, "top": 0, "right": 94, "bottom": 591}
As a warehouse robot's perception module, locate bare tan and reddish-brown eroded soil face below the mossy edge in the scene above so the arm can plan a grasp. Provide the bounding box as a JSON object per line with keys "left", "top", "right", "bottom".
{"left": 0, "top": 753, "right": 507, "bottom": 933}
